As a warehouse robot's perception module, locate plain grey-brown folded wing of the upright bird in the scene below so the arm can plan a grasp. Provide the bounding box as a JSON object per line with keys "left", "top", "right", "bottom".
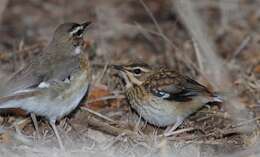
{"left": 0, "top": 51, "right": 79, "bottom": 96}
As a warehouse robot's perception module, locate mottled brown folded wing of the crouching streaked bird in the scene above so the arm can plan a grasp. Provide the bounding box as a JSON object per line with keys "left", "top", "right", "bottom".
{"left": 145, "top": 71, "right": 211, "bottom": 102}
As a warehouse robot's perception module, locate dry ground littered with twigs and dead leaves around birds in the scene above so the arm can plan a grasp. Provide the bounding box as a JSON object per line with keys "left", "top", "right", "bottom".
{"left": 0, "top": 0, "right": 260, "bottom": 157}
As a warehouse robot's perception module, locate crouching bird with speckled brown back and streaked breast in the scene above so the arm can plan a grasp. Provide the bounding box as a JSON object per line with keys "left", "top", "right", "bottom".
{"left": 111, "top": 62, "right": 223, "bottom": 136}
